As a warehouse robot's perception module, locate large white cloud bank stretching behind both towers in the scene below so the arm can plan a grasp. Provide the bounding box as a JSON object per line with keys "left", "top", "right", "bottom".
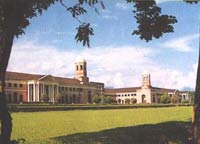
{"left": 8, "top": 41, "right": 197, "bottom": 89}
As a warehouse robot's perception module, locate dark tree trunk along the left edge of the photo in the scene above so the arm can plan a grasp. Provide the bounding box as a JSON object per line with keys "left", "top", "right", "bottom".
{"left": 0, "top": 31, "right": 14, "bottom": 144}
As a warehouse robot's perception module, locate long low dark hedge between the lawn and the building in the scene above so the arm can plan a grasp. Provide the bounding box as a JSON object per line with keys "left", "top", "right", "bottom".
{"left": 9, "top": 104, "right": 191, "bottom": 112}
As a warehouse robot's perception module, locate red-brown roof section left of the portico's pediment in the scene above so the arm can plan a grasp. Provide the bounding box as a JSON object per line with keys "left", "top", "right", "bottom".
{"left": 6, "top": 72, "right": 44, "bottom": 81}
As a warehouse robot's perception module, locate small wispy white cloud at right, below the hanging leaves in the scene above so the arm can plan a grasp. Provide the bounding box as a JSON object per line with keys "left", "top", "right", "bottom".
{"left": 163, "top": 34, "right": 199, "bottom": 52}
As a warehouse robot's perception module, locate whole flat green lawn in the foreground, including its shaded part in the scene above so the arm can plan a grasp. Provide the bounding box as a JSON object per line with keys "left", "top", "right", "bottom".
{"left": 12, "top": 107, "right": 192, "bottom": 144}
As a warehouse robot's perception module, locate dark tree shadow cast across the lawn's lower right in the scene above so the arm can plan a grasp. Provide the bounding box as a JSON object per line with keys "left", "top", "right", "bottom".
{"left": 52, "top": 121, "right": 191, "bottom": 144}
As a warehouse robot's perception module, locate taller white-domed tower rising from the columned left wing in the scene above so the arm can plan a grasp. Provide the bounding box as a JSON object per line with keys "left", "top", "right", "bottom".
{"left": 75, "top": 57, "right": 89, "bottom": 83}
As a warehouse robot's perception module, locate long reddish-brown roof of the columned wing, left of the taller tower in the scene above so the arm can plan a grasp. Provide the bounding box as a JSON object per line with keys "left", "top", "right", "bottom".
{"left": 6, "top": 72, "right": 80, "bottom": 85}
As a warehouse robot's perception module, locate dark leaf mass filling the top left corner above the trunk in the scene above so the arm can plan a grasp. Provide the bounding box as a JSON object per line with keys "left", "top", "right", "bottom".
{"left": 0, "top": 0, "right": 58, "bottom": 37}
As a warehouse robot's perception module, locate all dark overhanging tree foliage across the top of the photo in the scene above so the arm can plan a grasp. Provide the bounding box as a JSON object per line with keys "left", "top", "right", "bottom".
{"left": 0, "top": 0, "right": 181, "bottom": 47}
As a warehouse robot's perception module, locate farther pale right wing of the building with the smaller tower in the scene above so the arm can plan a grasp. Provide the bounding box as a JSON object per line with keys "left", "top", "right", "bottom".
{"left": 105, "top": 73, "right": 189, "bottom": 104}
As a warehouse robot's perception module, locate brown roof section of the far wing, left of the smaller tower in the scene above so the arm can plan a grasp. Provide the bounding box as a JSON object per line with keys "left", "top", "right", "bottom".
{"left": 105, "top": 87, "right": 141, "bottom": 93}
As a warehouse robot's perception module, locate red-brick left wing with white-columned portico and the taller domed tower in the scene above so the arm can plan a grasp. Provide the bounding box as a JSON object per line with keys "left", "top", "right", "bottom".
{"left": 5, "top": 57, "right": 104, "bottom": 104}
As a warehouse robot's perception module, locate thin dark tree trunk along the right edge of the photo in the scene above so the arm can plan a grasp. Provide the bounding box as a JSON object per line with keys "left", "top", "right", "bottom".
{"left": 192, "top": 40, "right": 200, "bottom": 144}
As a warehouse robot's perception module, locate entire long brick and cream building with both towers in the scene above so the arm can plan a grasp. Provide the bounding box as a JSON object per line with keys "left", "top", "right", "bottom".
{"left": 6, "top": 57, "right": 189, "bottom": 104}
